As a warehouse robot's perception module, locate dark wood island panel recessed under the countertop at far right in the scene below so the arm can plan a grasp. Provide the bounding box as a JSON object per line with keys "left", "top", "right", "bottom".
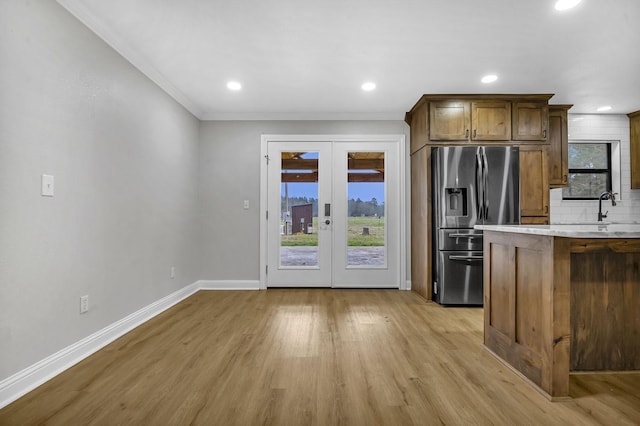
{"left": 571, "top": 240, "right": 640, "bottom": 371}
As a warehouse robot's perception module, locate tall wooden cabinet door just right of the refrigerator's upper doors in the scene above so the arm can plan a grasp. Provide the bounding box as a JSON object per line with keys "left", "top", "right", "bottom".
{"left": 520, "top": 145, "right": 549, "bottom": 217}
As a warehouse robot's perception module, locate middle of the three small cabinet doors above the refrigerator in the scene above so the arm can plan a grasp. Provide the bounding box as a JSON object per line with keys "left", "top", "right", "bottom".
{"left": 471, "top": 101, "right": 511, "bottom": 141}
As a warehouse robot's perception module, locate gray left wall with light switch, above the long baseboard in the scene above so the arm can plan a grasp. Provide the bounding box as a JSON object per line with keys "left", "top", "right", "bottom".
{"left": 0, "top": 0, "right": 200, "bottom": 380}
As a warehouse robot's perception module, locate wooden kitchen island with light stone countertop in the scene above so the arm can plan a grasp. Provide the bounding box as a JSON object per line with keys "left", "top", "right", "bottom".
{"left": 476, "top": 224, "right": 640, "bottom": 400}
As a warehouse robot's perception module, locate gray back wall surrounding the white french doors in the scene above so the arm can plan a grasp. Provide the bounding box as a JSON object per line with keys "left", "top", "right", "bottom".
{"left": 199, "top": 121, "right": 409, "bottom": 280}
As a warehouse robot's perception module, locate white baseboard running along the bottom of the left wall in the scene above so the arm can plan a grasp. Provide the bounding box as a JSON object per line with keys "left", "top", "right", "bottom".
{"left": 0, "top": 282, "right": 200, "bottom": 408}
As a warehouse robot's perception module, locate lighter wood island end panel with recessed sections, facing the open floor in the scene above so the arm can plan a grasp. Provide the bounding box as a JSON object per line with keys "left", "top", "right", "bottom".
{"left": 483, "top": 231, "right": 569, "bottom": 396}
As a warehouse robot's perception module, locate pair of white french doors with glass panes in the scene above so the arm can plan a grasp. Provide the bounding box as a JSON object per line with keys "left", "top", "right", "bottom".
{"left": 263, "top": 139, "right": 402, "bottom": 288}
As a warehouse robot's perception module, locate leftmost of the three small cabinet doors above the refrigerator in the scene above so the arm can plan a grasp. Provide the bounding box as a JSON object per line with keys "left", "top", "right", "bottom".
{"left": 429, "top": 101, "right": 471, "bottom": 141}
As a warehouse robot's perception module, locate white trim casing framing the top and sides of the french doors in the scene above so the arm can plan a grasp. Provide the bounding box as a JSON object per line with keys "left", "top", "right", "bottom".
{"left": 260, "top": 134, "right": 408, "bottom": 290}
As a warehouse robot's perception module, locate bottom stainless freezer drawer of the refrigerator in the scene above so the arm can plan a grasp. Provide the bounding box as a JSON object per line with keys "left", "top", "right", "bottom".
{"left": 434, "top": 251, "right": 483, "bottom": 306}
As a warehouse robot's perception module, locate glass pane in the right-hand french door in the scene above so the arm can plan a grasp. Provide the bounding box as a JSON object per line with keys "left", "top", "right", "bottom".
{"left": 346, "top": 152, "right": 386, "bottom": 267}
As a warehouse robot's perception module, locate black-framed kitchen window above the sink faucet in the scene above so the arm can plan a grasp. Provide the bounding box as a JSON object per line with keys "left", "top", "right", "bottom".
{"left": 562, "top": 142, "right": 612, "bottom": 200}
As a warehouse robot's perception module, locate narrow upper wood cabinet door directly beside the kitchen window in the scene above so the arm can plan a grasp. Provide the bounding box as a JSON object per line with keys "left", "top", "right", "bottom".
{"left": 547, "top": 105, "right": 569, "bottom": 188}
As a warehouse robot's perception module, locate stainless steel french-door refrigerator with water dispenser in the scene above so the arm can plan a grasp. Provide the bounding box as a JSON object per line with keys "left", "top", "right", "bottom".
{"left": 431, "top": 146, "right": 520, "bottom": 305}
